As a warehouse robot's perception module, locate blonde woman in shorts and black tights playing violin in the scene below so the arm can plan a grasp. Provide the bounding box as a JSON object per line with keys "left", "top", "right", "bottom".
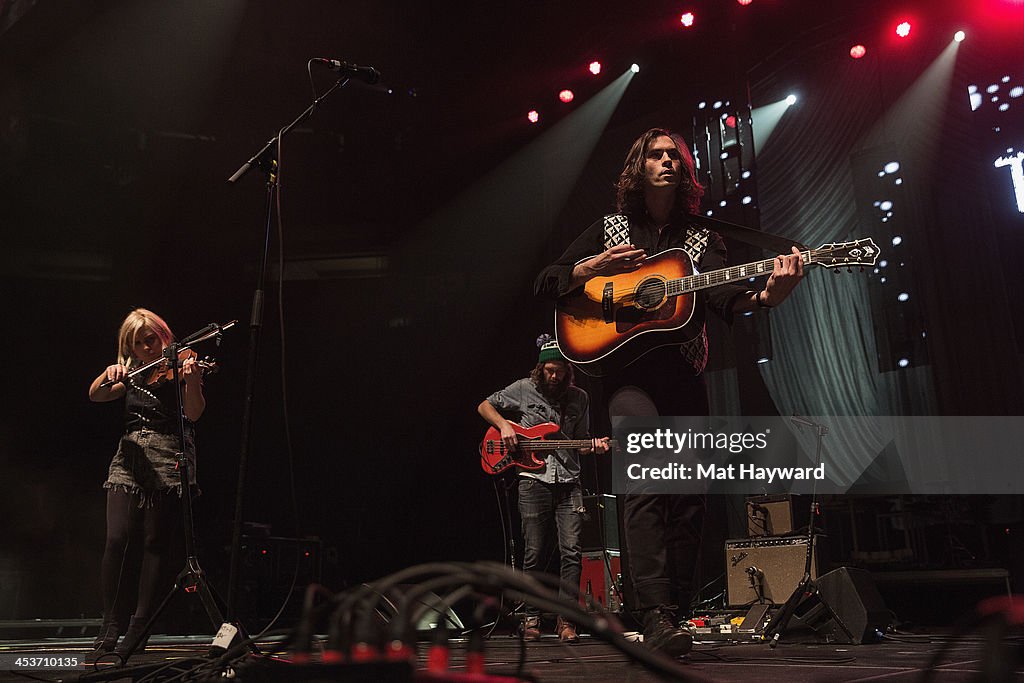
{"left": 89, "top": 308, "right": 206, "bottom": 654}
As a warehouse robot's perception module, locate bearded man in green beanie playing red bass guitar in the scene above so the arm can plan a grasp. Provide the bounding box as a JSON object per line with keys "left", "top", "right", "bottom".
{"left": 476, "top": 336, "right": 608, "bottom": 643}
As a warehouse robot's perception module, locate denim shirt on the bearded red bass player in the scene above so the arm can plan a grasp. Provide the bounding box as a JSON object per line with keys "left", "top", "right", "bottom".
{"left": 487, "top": 377, "right": 590, "bottom": 483}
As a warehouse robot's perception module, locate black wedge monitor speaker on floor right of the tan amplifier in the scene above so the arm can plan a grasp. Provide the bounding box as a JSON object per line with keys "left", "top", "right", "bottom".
{"left": 790, "top": 567, "right": 892, "bottom": 645}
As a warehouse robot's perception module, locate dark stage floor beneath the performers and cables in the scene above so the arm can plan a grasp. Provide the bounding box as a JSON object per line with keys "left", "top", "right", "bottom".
{"left": 0, "top": 633, "right": 1024, "bottom": 683}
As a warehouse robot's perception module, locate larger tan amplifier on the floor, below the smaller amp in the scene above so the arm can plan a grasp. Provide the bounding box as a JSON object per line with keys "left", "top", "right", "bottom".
{"left": 725, "top": 536, "right": 820, "bottom": 606}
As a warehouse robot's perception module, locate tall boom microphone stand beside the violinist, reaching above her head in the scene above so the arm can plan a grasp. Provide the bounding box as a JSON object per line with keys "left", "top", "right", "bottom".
{"left": 227, "top": 76, "right": 349, "bottom": 622}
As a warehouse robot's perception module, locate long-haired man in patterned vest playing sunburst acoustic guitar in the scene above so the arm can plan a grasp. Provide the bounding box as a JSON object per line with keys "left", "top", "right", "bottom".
{"left": 535, "top": 128, "right": 803, "bottom": 656}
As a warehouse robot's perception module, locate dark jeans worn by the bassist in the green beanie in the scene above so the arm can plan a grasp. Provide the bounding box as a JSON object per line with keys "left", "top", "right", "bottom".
{"left": 519, "top": 477, "right": 583, "bottom": 615}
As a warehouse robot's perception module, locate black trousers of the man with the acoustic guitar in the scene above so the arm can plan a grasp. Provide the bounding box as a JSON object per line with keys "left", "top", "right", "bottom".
{"left": 604, "top": 346, "right": 709, "bottom": 610}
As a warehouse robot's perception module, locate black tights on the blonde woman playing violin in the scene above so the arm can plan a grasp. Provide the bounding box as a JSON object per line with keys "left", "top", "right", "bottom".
{"left": 99, "top": 488, "right": 181, "bottom": 621}
